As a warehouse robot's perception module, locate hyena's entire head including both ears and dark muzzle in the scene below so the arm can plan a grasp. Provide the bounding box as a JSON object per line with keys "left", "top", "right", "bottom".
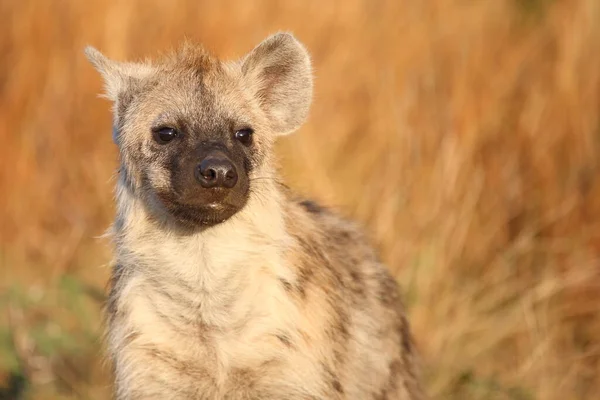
{"left": 86, "top": 33, "right": 312, "bottom": 227}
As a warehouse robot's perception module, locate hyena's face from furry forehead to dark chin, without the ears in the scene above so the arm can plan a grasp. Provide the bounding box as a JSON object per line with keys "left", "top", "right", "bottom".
{"left": 122, "top": 66, "right": 268, "bottom": 228}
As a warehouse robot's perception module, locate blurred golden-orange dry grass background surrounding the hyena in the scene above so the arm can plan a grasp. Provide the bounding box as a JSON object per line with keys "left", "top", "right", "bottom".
{"left": 0, "top": 0, "right": 600, "bottom": 400}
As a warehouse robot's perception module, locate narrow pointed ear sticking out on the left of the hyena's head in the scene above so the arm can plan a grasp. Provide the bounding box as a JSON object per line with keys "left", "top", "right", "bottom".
{"left": 85, "top": 46, "right": 153, "bottom": 102}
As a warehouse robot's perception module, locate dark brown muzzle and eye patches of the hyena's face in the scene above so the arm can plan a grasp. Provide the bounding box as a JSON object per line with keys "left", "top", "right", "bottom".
{"left": 152, "top": 122, "right": 253, "bottom": 226}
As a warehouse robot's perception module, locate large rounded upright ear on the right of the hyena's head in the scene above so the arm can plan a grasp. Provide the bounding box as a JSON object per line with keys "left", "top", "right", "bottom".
{"left": 242, "top": 33, "right": 312, "bottom": 135}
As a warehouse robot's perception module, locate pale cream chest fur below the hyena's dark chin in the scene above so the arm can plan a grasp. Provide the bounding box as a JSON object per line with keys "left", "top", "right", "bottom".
{"left": 109, "top": 193, "right": 318, "bottom": 396}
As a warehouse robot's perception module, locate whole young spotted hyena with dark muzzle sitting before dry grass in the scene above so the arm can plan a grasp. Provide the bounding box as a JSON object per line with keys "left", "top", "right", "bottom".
{"left": 86, "top": 33, "right": 423, "bottom": 400}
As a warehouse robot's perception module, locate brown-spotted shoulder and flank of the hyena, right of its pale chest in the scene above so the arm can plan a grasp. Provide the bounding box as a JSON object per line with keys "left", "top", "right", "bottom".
{"left": 287, "top": 198, "right": 420, "bottom": 399}
